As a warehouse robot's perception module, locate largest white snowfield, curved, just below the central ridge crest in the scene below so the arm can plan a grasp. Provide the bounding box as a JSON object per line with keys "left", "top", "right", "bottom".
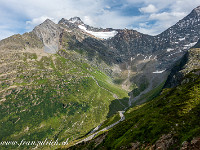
{"left": 78, "top": 25, "right": 118, "bottom": 39}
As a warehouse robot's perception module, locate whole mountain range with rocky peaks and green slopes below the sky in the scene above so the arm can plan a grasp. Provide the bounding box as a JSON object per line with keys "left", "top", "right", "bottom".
{"left": 0, "top": 6, "right": 200, "bottom": 149}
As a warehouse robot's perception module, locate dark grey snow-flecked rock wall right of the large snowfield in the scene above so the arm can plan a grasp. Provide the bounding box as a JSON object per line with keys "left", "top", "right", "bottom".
{"left": 107, "top": 7, "right": 200, "bottom": 68}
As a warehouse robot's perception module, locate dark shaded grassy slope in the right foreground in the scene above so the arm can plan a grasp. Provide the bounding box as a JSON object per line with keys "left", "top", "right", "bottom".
{"left": 67, "top": 70, "right": 200, "bottom": 149}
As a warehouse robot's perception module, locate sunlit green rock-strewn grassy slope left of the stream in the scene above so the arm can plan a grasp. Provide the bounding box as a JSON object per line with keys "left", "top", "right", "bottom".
{"left": 0, "top": 46, "right": 128, "bottom": 148}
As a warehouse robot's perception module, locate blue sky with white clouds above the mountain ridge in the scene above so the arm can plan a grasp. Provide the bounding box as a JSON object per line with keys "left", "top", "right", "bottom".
{"left": 0, "top": 0, "right": 200, "bottom": 39}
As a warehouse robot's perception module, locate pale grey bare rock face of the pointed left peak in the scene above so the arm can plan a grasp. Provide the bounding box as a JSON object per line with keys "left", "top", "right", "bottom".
{"left": 33, "top": 19, "right": 61, "bottom": 53}
